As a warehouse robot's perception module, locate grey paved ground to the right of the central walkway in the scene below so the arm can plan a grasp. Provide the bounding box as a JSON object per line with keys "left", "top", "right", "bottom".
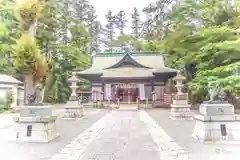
{"left": 147, "top": 109, "right": 240, "bottom": 160}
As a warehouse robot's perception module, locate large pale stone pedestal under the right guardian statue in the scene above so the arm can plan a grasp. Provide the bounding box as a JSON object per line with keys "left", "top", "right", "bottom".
{"left": 192, "top": 102, "right": 240, "bottom": 143}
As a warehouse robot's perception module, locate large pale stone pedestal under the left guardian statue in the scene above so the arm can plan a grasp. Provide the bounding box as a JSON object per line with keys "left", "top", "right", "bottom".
{"left": 13, "top": 105, "right": 59, "bottom": 143}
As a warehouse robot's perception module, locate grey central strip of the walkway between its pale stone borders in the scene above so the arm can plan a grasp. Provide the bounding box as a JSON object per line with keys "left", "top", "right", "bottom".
{"left": 81, "top": 111, "right": 160, "bottom": 160}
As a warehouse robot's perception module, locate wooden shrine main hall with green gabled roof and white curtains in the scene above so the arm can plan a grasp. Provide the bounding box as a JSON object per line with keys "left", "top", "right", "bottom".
{"left": 77, "top": 52, "right": 177, "bottom": 103}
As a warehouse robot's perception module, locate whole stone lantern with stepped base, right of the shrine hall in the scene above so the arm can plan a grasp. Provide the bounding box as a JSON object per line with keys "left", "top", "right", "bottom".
{"left": 170, "top": 71, "right": 192, "bottom": 120}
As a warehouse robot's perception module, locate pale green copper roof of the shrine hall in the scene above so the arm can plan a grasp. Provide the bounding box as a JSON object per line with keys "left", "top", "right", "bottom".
{"left": 78, "top": 52, "right": 176, "bottom": 77}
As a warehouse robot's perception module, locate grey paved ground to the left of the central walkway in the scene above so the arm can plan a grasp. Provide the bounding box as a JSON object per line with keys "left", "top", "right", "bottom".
{"left": 0, "top": 108, "right": 108, "bottom": 160}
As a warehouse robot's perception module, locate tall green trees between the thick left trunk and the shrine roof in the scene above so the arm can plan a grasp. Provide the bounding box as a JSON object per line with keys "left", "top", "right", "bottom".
{"left": 41, "top": 2, "right": 90, "bottom": 103}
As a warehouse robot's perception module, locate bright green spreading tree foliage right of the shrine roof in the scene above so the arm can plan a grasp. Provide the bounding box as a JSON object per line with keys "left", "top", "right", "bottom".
{"left": 150, "top": 0, "right": 240, "bottom": 105}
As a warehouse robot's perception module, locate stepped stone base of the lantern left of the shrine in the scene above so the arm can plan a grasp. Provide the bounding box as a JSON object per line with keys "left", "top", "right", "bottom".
{"left": 63, "top": 101, "right": 83, "bottom": 120}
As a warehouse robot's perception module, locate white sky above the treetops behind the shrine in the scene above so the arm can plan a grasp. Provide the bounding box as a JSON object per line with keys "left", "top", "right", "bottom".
{"left": 90, "top": 0, "right": 157, "bottom": 32}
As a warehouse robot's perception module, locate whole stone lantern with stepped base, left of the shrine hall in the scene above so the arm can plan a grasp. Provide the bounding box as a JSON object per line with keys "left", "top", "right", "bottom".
{"left": 63, "top": 72, "right": 83, "bottom": 119}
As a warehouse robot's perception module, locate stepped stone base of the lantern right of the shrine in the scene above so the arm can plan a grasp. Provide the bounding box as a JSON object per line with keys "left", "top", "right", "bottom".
{"left": 170, "top": 100, "right": 193, "bottom": 120}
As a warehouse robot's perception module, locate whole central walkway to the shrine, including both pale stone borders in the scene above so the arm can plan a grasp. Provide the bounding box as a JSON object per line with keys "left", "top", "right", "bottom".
{"left": 51, "top": 111, "right": 188, "bottom": 160}
